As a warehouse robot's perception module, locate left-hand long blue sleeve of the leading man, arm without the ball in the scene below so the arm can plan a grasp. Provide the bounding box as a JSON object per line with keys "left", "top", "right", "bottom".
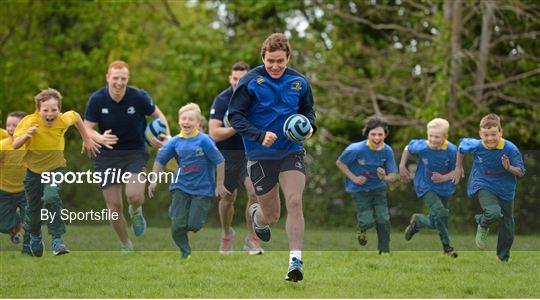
{"left": 229, "top": 80, "right": 266, "bottom": 143}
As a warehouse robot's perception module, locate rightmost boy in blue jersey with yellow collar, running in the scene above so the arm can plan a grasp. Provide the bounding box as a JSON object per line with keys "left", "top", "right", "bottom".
{"left": 453, "top": 114, "right": 525, "bottom": 261}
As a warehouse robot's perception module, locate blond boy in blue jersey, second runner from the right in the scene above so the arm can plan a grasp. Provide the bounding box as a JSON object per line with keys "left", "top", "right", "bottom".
{"left": 399, "top": 118, "right": 457, "bottom": 258}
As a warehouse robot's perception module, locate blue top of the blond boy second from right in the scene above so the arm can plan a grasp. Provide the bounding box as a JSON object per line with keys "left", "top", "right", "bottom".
{"left": 407, "top": 139, "right": 457, "bottom": 197}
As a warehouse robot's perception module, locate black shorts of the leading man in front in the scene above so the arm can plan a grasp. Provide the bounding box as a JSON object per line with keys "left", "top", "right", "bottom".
{"left": 247, "top": 150, "right": 306, "bottom": 196}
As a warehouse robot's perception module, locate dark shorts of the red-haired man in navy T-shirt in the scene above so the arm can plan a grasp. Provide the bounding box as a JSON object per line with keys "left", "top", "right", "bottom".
{"left": 94, "top": 150, "right": 150, "bottom": 190}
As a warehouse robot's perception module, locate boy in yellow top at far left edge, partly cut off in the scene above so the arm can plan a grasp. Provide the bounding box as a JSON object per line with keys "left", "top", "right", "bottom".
{"left": 0, "top": 111, "right": 28, "bottom": 248}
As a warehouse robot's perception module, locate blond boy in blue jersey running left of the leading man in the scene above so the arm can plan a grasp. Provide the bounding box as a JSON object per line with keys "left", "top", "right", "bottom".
{"left": 148, "top": 103, "right": 229, "bottom": 258}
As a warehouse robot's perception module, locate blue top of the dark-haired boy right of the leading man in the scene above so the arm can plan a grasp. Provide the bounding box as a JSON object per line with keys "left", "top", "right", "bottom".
{"left": 339, "top": 140, "right": 397, "bottom": 193}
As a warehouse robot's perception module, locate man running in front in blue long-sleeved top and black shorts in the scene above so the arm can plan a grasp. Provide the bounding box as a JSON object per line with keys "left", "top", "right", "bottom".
{"left": 229, "top": 33, "right": 316, "bottom": 282}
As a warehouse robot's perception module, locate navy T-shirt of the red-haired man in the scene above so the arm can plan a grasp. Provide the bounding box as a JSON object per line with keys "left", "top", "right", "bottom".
{"left": 84, "top": 86, "right": 156, "bottom": 153}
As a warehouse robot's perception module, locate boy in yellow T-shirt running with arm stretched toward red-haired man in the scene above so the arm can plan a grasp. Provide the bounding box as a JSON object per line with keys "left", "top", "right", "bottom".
{"left": 13, "top": 88, "right": 99, "bottom": 257}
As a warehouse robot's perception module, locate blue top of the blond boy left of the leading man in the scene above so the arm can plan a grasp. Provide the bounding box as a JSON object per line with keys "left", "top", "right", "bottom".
{"left": 156, "top": 132, "right": 225, "bottom": 197}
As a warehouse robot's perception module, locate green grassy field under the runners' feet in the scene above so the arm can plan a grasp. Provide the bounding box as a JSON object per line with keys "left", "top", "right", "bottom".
{"left": 0, "top": 226, "right": 540, "bottom": 298}
